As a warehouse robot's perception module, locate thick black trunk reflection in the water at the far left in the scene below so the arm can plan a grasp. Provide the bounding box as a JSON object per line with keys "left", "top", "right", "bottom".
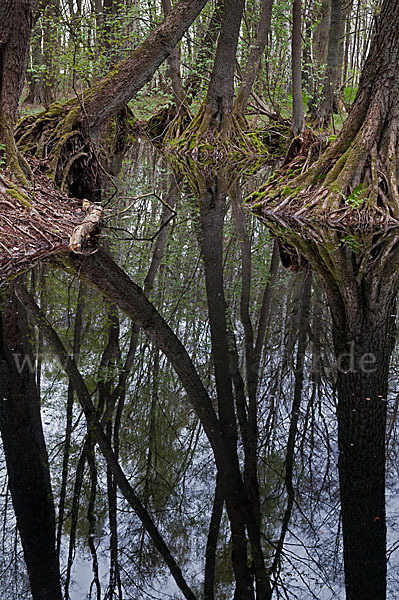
{"left": 0, "top": 288, "right": 62, "bottom": 600}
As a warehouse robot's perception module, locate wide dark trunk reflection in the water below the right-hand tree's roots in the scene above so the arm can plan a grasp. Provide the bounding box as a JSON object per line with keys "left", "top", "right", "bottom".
{"left": 326, "top": 251, "right": 398, "bottom": 600}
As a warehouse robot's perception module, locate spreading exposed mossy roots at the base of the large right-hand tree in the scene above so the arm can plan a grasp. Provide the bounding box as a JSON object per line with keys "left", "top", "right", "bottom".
{"left": 247, "top": 108, "right": 399, "bottom": 224}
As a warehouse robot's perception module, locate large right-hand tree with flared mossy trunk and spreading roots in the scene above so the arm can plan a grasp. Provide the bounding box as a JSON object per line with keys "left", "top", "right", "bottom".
{"left": 248, "top": 0, "right": 399, "bottom": 223}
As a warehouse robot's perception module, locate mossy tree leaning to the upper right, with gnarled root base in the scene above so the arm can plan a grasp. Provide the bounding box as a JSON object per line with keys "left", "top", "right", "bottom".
{"left": 16, "top": 0, "right": 207, "bottom": 192}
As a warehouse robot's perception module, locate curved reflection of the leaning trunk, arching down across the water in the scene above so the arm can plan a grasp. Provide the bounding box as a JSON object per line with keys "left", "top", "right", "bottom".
{"left": 62, "top": 251, "right": 276, "bottom": 600}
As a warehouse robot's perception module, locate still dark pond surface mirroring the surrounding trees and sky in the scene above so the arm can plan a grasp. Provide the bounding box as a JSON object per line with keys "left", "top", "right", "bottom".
{"left": 0, "top": 156, "right": 399, "bottom": 600}
